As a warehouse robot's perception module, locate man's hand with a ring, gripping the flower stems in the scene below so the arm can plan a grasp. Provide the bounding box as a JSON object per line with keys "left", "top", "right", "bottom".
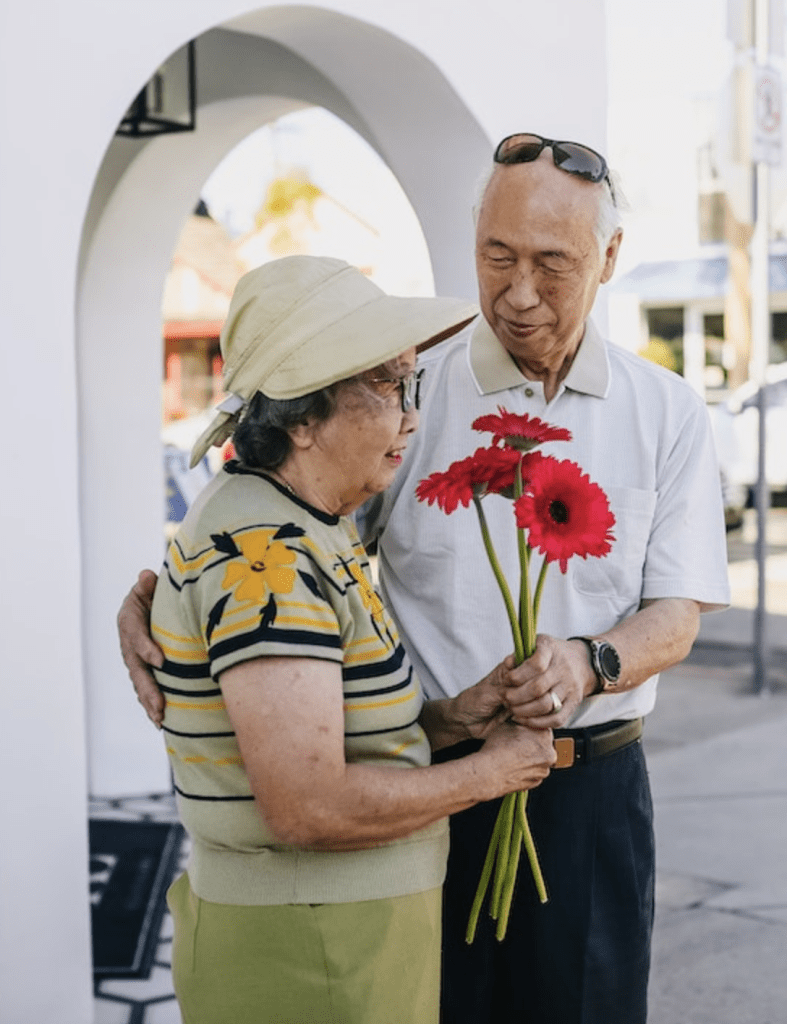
{"left": 502, "top": 634, "right": 596, "bottom": 729}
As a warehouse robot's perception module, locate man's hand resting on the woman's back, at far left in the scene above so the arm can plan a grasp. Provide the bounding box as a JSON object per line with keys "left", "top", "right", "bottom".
{"left": 118, "top": 569, "right": 164, "bottom": 729}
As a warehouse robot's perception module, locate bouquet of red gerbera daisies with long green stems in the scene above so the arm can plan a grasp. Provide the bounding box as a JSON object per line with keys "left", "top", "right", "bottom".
{"left": 416, "top": 407, "right": 615, "bottom": 943}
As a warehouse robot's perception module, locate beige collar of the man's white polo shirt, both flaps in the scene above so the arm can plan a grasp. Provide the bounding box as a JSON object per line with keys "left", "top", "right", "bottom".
{"left": 470, "top": 316, "right": 610, "bottom": 398}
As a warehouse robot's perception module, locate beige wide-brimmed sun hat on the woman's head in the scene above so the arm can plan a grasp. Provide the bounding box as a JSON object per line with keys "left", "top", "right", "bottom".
{"left": 191, "top": 256, "right": 478, "bottom": 466}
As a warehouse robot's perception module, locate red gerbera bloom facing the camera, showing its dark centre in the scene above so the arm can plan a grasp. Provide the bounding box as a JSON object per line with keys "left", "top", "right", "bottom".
{"left": 514, "top": 457, "right": 615, "bottom": 572}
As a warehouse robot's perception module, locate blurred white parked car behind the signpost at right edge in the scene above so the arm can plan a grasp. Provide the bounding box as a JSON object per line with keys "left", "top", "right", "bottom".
{"left": 709, "top": 362, "right": 787, "bottom": 516}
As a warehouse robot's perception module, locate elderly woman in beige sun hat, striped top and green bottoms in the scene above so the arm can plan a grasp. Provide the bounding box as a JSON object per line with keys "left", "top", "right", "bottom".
{"left": 127, "top": 257, "right": 554, "bottom": 1024}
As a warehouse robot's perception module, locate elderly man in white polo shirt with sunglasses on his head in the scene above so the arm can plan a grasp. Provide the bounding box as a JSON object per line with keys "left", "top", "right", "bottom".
{"left": 121, "top": 134, "right": 729, "bottom": 1024}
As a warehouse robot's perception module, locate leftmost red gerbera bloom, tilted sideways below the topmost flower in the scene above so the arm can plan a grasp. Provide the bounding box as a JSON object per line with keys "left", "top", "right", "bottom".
{"left": 416, "top": 447, "right": 533, "bottom": 514}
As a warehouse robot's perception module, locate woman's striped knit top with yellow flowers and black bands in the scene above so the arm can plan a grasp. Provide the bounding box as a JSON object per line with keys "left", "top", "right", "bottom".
{"left": 151, "top": 463, "right": 447, "bottom": 905}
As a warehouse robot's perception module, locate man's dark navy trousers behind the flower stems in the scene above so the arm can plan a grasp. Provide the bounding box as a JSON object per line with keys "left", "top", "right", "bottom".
{"left": 436, "top": 742, "right": 655, "bottom": 1024}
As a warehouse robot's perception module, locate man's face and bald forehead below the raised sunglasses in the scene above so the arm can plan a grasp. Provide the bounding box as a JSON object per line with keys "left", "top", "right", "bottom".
{"left": 476, "top": 150, "right": 621, "bottom": 369}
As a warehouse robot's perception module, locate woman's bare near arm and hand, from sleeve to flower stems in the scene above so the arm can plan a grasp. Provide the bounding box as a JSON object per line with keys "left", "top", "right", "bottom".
{"left": 220, "top": 656, "right": 555, "bottom": 850}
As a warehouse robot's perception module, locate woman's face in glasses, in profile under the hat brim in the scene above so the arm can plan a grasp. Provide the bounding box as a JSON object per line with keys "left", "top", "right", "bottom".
{"left": 313, "top": 348, "right": 419, "bottom": 514}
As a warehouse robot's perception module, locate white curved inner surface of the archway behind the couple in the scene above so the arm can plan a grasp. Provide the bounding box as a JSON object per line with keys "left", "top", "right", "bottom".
{"left": 77, "top": 14, "right": 489, "bottom": 796}
